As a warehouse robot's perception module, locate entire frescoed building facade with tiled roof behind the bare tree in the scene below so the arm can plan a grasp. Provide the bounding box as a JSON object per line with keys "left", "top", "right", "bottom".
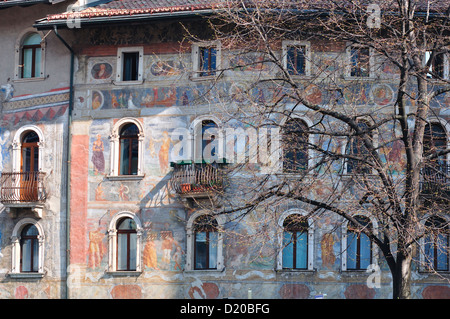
{"left": 0, "top": 1, "right": 450, "bottom": 299}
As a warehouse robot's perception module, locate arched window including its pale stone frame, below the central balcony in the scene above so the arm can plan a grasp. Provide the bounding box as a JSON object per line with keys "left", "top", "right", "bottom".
{"left": 186, "top": 212, "right": 224, "bottom": 271}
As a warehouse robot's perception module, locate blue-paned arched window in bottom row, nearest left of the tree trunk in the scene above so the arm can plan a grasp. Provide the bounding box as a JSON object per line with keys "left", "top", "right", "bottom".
{"left": 346, "top": 216, "right": 372, "bottom": 270}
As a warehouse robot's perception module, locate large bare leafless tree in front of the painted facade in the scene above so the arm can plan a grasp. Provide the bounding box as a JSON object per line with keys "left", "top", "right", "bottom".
{"left": 178, "top": 0, "right": 450, "bottom": 298}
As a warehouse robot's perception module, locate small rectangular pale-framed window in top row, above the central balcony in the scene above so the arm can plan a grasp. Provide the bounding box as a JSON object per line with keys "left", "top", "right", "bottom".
{"left": 192, "top": 41, "right": 221, "bottom": 79}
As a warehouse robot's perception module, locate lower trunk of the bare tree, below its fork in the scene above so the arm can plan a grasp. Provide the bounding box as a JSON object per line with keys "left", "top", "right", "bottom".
{"left": 392, "top": 252, "right": 412, "bottom": 299}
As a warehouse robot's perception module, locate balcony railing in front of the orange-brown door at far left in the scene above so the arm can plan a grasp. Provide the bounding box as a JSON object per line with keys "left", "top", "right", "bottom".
{"left": 0, "top": 172, "right": 47, "bottom": 204}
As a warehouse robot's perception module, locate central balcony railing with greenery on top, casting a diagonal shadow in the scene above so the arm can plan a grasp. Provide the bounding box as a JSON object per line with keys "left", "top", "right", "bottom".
{"left": 171, "top": 164, "right": 223, "bottom": 197}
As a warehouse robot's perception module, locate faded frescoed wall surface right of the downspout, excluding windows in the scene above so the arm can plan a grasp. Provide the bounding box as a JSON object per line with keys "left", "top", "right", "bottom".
{"left": 63, "top": 25, "right": 450, "bottom": 298}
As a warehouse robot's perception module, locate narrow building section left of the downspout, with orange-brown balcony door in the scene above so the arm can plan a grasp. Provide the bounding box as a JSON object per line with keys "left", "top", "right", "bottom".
{"left": 0, "top": 1, "right": 75, "bottom": 298}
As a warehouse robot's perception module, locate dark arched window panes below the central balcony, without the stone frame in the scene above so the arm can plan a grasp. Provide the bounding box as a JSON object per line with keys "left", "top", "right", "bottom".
{"left": 194, "top": 215, "right": 219, "bottom": 269}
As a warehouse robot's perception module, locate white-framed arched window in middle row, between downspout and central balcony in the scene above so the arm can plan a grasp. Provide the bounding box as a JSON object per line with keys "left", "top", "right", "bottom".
{"left": 110, "top": 118, "right": 144, "bottom": 177}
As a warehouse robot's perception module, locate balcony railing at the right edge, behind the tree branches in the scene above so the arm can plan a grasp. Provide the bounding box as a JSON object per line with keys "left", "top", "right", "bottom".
{"left": 420, "top": 164, "right": 450, "bottom": 197}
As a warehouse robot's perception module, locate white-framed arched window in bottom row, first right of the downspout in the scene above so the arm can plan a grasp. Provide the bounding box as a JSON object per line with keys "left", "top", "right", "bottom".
{"left": 108, "top": 212, "right": 143, "bottom": 272}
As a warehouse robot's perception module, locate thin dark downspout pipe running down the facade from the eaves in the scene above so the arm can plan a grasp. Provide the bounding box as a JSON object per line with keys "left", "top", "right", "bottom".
{"left": 53, "top": 26, "right": 75, "bottom": 299}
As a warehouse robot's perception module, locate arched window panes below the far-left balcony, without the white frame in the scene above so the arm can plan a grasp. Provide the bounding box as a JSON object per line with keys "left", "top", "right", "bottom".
{"left": 20, "top": 224, "right": 39, "bottom": 272}
